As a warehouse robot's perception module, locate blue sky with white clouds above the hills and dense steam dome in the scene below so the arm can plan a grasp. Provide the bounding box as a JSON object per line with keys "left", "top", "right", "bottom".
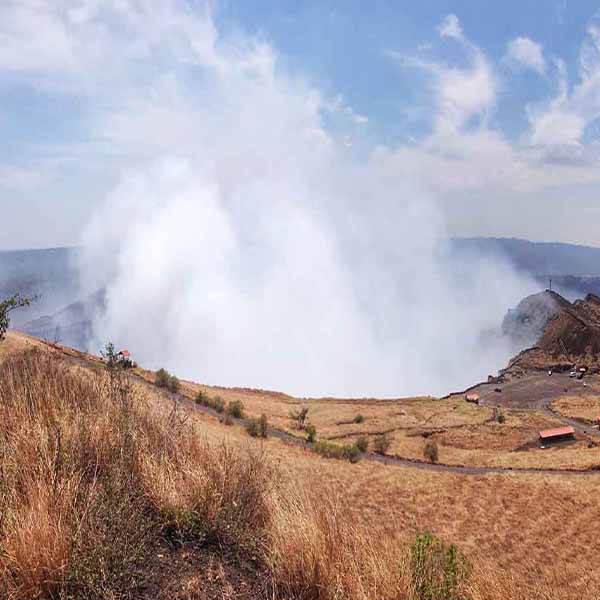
{"left": 0, "top": 0, "right": 600, "bottom": 249}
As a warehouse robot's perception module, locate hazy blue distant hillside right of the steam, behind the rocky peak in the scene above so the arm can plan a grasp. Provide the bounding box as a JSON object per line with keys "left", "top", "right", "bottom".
{"left": 447, "top": 237, "right": 600, "bottom": 278}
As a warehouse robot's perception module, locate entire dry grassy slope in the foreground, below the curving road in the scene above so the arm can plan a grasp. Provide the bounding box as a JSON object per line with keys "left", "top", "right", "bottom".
{"left": 0, "top": 336, "right": 600, "bottom": 600}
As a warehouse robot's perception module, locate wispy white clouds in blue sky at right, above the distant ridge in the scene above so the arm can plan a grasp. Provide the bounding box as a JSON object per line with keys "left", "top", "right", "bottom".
{"left": 384, "top": 11, "right": 600, "bottom": 243}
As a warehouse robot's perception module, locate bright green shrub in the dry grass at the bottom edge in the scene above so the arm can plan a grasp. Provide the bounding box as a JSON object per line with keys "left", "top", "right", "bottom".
{"left": 410, "top": 531, "right": 471, "bottom": 600}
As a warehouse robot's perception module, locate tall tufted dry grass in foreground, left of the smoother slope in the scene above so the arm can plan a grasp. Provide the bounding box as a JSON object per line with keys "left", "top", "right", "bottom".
{"left": 0, "top": 350, "right": 592, "bottom": 600}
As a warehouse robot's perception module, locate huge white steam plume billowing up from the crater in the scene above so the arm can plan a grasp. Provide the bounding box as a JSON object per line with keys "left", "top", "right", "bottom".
{"left": 69, "top": 2, "right": 530, "bottom": 397}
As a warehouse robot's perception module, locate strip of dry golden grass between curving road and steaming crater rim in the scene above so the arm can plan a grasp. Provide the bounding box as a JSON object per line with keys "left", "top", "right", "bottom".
{"left": 164, "top": 372, "right": 600, "bottom": 470}
